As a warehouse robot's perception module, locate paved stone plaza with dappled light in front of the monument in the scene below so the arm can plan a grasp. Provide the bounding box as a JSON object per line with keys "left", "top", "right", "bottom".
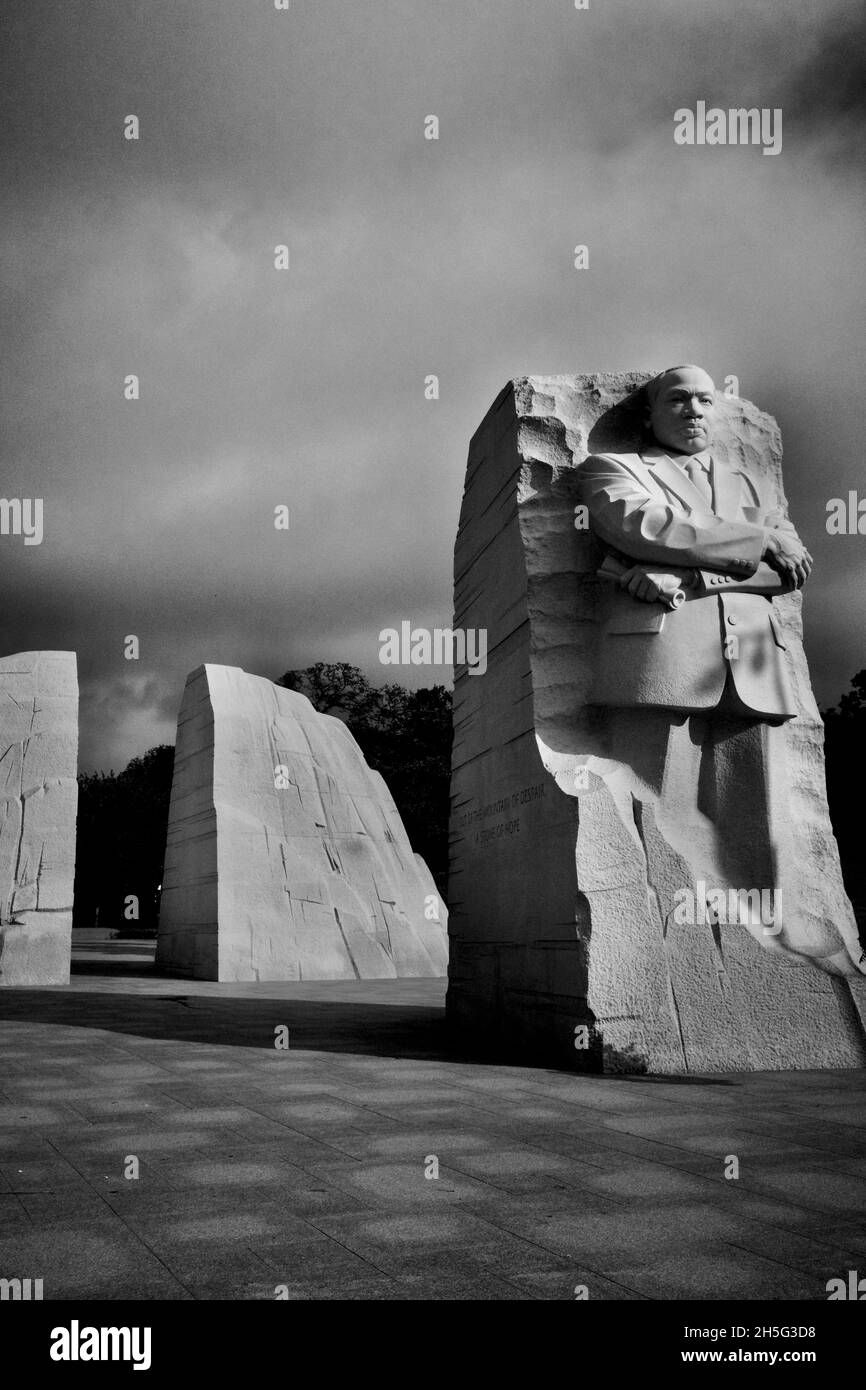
{"left": 0, "top": 942, "right": 866, "bottom": 1301}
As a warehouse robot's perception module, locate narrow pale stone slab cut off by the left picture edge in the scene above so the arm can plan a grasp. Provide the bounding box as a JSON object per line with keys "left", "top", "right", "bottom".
{"left": 0, "top": 652, "right": 78, "bottom": 986}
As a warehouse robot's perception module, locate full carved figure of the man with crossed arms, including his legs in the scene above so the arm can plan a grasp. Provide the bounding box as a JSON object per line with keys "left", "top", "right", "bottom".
{"left": 578, "top": 366, "right": 862, "bottom": 973}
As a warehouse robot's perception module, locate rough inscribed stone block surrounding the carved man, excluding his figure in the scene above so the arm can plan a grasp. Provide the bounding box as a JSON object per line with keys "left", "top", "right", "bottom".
{"left": 448, "top": 373, "right": 866, "bottom": 1073}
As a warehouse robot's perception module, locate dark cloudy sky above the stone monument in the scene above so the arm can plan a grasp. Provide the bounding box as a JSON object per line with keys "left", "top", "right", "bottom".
{"left": 0, "top": 0, "right": 866, "bottom": 769}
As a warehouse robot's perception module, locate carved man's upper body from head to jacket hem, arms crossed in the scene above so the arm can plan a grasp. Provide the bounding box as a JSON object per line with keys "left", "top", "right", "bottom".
{"left": 580, "top": 366, "right": 812, "bottom": 723}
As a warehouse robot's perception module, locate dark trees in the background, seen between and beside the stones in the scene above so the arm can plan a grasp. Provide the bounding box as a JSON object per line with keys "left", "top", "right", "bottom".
{"left": 72, "top": 662, "right": 866, "bottom": 935}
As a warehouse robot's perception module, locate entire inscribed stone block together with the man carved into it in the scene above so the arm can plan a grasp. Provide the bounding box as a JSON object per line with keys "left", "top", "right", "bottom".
{"left": 448, "top": 367, "right": 866, "bottom": 1072}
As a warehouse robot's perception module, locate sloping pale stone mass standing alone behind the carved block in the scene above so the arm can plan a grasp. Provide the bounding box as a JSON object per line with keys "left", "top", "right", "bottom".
{"left": 157, "top": 666, "right": 448, "bottom": 980}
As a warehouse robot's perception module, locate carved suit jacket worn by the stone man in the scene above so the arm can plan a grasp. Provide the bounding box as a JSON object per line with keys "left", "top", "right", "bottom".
{"left": 578, "top": 446, "right": 796, "bottom": 723}
